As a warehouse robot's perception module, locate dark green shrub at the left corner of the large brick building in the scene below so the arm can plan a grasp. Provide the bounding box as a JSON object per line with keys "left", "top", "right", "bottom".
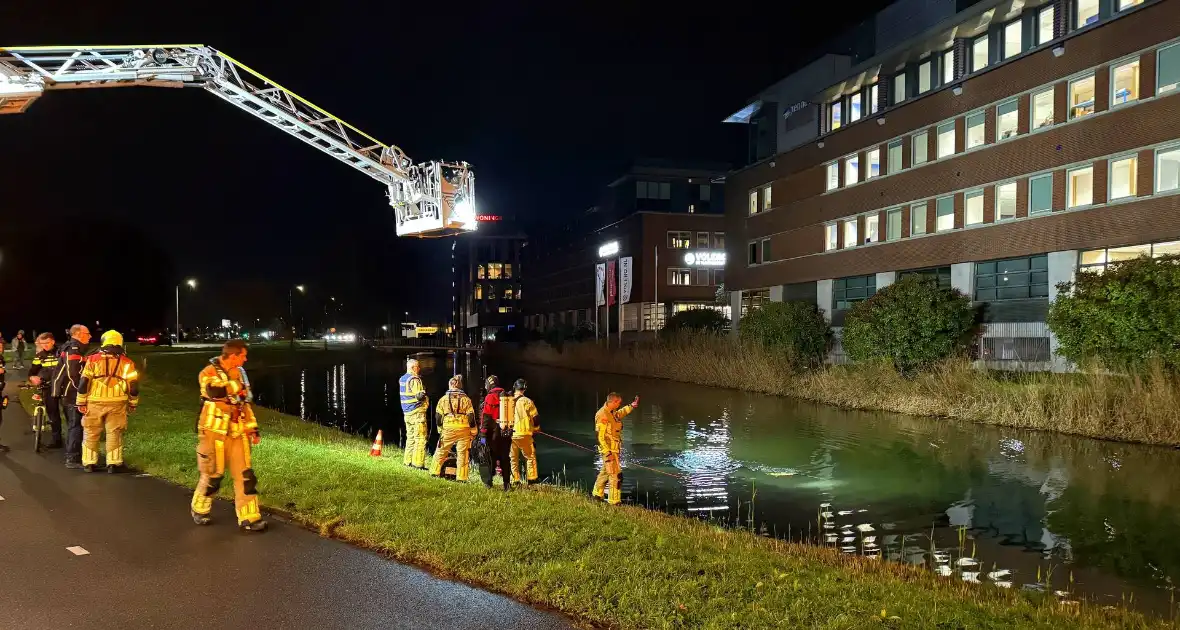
{"left": 739, "top": 302, "right": 832, "bottom": 367}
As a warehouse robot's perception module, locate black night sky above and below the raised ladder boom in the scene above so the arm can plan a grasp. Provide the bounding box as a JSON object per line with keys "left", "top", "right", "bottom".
{"left": 0, "top": 0, "right": 881, "bottom": 337}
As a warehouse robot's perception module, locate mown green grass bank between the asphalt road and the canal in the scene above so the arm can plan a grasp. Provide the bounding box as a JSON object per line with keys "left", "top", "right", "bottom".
{"left": 36, "top": 353, "right": 1163, "bottom": 629}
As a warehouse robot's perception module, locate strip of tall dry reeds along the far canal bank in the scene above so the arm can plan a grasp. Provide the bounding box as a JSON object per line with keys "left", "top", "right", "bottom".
{"left": 516, "top": 335, "right": 1180, "bottom": 446}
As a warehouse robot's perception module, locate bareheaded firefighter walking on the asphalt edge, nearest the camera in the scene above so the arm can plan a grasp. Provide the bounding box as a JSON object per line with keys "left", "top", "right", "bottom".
{"left": 190, "top": 339, "right": 267, "bottom": 532}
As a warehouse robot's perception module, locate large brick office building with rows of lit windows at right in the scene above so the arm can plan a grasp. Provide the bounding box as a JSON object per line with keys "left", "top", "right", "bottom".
{"left": 726, "top": 0, "right": 1180, "bottom": 368}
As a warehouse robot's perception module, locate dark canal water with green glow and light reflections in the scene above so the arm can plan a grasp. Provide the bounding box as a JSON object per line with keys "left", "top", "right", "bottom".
{"left": 250, "top": 354, "right": 1180, "bottom": 616}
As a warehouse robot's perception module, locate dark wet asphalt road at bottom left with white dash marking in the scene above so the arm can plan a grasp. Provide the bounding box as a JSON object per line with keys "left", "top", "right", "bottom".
{"left": 0, "top": 370, "right": 571, "bottom": 630}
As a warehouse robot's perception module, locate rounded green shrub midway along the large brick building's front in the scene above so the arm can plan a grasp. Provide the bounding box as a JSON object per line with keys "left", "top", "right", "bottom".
{"left": 844, "top": 276, "right": 975, "bottom": 375}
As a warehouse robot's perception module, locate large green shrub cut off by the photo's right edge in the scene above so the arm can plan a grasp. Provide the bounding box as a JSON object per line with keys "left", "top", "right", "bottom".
{"left": 1048, "top": 256, "right": 1180, "bottom": 372}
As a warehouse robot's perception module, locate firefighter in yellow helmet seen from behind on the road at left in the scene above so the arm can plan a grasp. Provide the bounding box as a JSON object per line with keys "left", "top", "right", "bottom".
{"left": 77, "top": 330, "right": 139, "bottom": 473}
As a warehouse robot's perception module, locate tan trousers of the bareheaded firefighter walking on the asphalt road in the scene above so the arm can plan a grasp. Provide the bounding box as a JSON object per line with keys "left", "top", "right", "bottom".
{"left": 192, "top": 429, "right": 262, "bottom": 524}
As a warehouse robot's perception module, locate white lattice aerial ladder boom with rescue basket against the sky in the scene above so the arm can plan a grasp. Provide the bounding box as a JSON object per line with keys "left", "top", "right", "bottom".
{"left": 0, "top": 44, "right": 477, "bottom": 236}
